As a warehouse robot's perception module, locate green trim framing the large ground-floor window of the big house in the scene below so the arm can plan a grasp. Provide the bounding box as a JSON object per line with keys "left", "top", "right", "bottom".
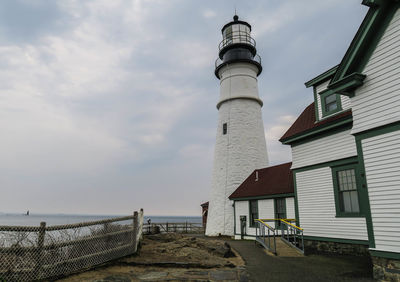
{"left": 331, "top": 164, "right": 365, "bottom": 217}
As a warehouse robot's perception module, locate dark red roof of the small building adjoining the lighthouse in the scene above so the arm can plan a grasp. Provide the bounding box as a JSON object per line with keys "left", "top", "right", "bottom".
{"left": 229, "top": 162, "right": 294, "bottom": 199}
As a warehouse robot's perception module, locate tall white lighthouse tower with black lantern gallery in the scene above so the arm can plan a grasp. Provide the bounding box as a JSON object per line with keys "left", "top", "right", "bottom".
{"left": 206, "top": 15, "right": 268, "bottom": 236}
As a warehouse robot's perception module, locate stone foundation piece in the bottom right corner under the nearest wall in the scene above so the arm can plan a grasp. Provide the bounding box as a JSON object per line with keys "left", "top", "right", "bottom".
{"left": 372, "top": 257, "right": 400, "bottom": 281}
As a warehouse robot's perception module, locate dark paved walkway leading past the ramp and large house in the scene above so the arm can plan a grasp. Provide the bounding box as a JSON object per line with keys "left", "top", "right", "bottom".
{"left": 227, "top": 240, "right": 374, "bottom": 282}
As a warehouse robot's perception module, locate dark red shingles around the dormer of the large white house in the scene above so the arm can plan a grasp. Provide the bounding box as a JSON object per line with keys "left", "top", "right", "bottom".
{"left": 279, "top": 103, "right": 352, "bottom": 142}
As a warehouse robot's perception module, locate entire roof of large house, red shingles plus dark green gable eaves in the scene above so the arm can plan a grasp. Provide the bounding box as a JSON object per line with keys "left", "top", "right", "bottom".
{"left": 279, "top": 0, "right": 400, "bottom": 144}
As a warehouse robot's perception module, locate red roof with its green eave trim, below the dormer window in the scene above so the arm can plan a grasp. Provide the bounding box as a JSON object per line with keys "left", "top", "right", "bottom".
{"left": 279, "top": 103, "right": 352, "bottom": 144}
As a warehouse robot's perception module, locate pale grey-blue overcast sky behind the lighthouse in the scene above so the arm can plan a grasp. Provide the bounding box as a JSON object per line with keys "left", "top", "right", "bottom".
{"left": 0, "top": 0, "right": 367, "bottom": 215}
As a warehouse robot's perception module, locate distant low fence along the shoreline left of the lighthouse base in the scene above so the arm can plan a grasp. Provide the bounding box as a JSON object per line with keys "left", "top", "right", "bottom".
{"left": 143, "top": 222, "right": 204, "bottom": 234}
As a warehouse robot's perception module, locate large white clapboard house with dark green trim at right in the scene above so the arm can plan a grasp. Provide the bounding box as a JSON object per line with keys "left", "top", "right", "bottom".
{"left": 280, "top": 0, "right": 400, "bottom": 277}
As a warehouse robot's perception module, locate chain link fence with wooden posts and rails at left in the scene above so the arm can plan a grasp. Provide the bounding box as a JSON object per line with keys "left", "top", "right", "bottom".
{"left": 0, "top": 210, "right": 143, "bottom": 281}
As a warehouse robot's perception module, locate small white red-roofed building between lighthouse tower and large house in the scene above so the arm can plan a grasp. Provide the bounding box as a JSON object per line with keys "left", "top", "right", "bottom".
{"left": 229, "top": 163, "right": 295, "bottom": 239}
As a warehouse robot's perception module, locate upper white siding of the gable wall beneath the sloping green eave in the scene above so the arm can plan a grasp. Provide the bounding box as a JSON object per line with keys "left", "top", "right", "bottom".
{"left": 351, "top": 9, "right": 400, "bottom": 133}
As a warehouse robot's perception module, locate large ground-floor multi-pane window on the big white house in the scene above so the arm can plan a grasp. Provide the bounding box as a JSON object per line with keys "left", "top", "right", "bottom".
{"left": 332, "top": 164, "right": 361, "bottom": 216}
